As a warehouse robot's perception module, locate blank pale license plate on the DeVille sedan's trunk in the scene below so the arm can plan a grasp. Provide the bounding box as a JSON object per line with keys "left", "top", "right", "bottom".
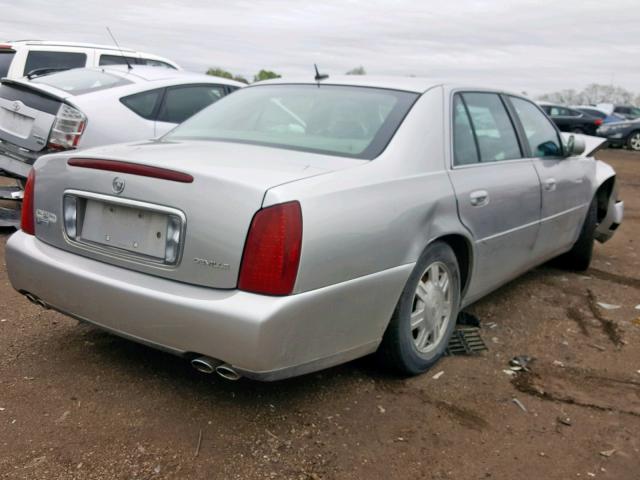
{"left": 81, "top": 200, "right": 168, "bottom": 259}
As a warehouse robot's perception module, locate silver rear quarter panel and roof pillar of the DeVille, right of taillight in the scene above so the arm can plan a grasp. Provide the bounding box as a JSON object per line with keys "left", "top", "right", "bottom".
{"left": 264, "top": 87, "right": 469, "bottom": 292}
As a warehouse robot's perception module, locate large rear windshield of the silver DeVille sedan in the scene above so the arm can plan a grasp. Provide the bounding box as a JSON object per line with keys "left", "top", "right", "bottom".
{"left": 165, "top": 85, "right": 418, "bottom": 160}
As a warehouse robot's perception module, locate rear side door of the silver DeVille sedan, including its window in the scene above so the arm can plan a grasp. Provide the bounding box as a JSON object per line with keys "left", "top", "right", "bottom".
{"left": 449, "top": 92, "right": 541, "bottom": 301}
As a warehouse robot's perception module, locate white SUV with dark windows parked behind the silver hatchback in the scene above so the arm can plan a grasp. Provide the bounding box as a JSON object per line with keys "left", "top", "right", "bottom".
{"left": 0, "top": 40, "right": 180, "bottom": 79}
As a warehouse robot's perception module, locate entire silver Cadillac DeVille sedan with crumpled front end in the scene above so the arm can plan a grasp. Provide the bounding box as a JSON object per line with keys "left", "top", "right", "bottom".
{"left": 6, "top": 77, "right": 623, "bottom": 380}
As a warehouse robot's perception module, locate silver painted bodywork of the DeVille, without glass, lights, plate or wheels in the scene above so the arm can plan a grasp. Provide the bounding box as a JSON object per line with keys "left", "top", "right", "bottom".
{"left": 6, "top": 77, "right": 622, "bottom": 380}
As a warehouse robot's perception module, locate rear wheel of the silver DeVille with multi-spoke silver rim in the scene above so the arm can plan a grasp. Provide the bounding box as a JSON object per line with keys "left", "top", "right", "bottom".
{"left": 378, "top": 241, "right": 460, "bottom": 375}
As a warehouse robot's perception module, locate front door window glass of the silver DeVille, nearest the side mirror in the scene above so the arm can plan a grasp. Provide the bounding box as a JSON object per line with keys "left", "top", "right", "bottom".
{"left": 509, "top": 97, "right": 562, "bottom": 157}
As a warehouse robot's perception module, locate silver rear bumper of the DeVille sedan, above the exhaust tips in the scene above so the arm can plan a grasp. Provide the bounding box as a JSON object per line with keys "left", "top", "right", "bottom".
{"left": 6, "top": 231, "right": 413, "bottom": 380}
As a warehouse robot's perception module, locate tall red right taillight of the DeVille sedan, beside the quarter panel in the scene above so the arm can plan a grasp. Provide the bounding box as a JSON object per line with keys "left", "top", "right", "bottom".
{"left": 238, "top": 202, "right": 302, "bottom": 295}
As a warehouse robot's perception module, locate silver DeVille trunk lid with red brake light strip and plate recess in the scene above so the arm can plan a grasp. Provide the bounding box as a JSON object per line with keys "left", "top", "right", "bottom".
{"left": 35, "top": 142, "right": 366, "bottom": 288}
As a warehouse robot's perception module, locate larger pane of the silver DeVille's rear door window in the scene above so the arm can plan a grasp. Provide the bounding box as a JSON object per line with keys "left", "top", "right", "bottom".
{"left": 462, "top": 93, "right": 522, "bottom": 162}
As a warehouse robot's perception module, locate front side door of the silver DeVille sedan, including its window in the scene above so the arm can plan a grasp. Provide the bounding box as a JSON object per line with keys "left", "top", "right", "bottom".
{"left": 507, "top": 96, "right": 595, "bottom": 258}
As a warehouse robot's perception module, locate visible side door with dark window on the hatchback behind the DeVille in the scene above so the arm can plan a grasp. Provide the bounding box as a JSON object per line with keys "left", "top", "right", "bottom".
{"left": 155, "top": 84, "right": 227, "bottom": 136}
